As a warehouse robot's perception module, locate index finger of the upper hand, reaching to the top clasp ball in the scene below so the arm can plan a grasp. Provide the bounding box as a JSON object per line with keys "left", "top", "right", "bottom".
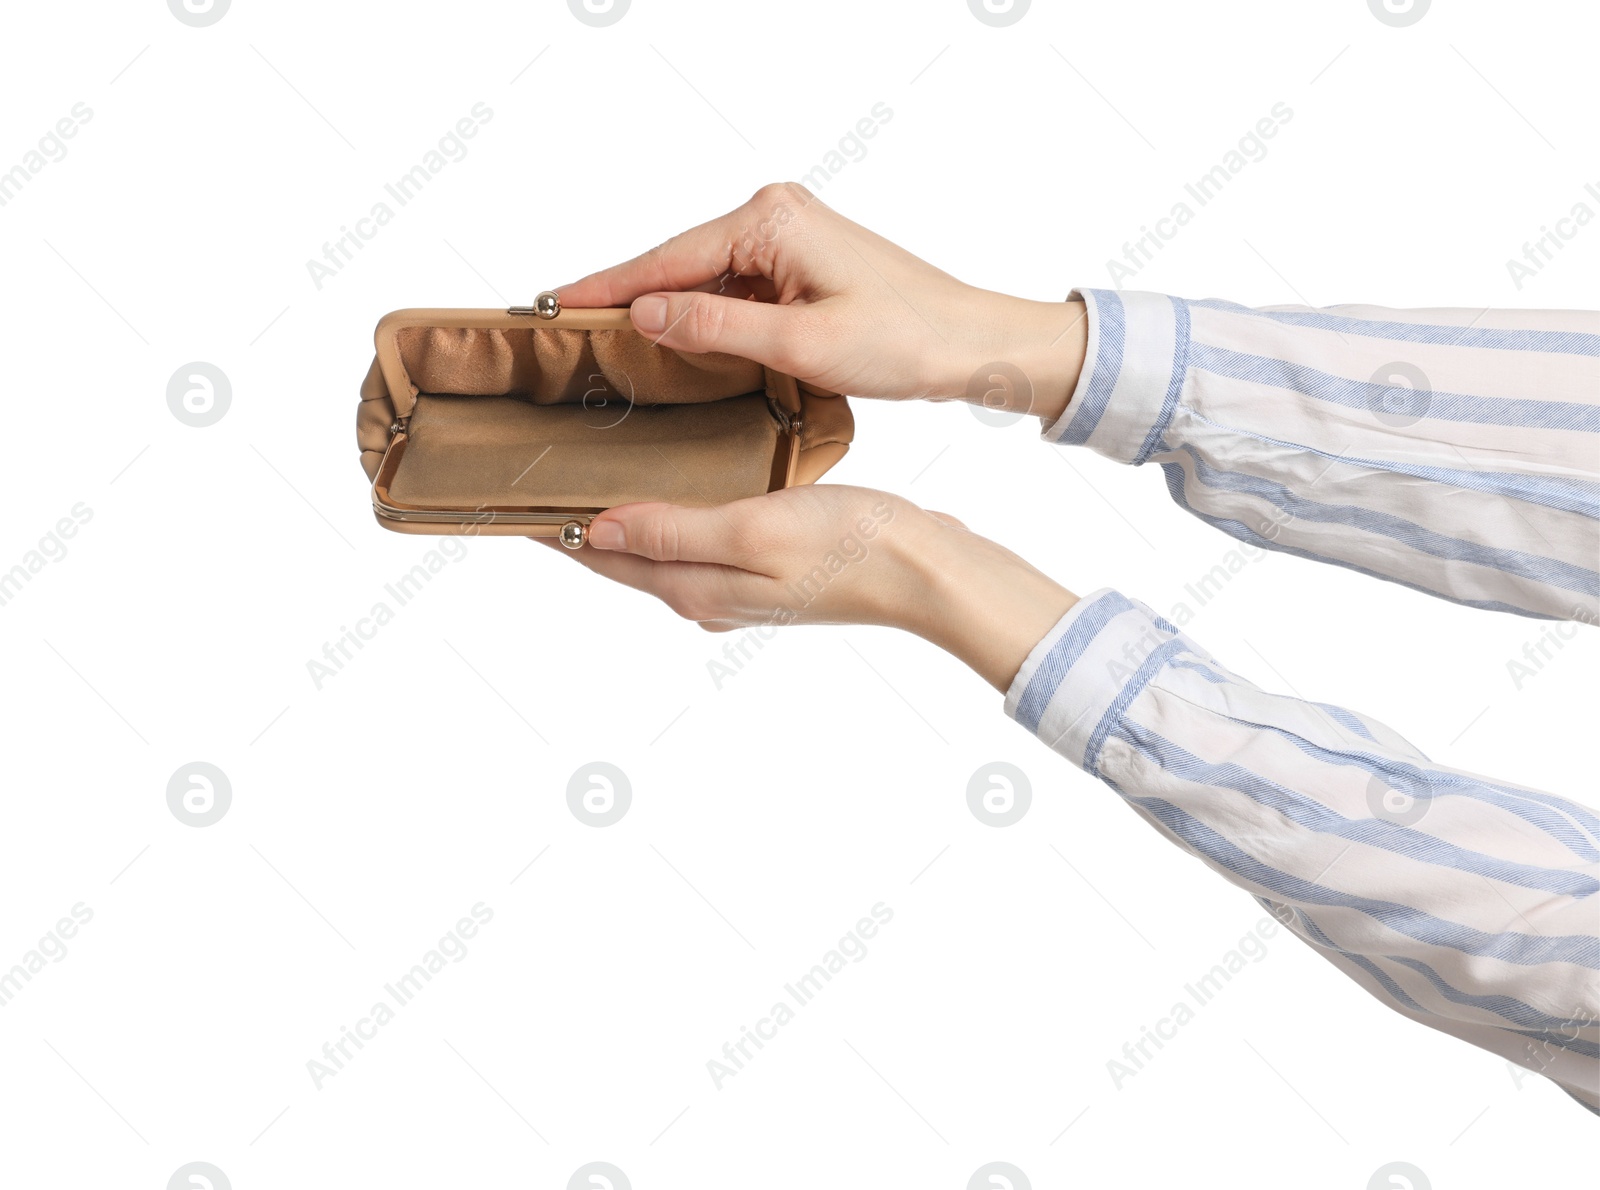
{"left": 560, "top": 184, "right": 810, "bottom": 307}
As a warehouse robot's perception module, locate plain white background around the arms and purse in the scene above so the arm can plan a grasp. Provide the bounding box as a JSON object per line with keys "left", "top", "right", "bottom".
{"left": 0, "top": 0, "right": 1600, "bottom": 1190}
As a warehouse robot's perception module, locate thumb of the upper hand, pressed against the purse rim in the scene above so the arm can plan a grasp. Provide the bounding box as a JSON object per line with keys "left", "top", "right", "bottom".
{"left": 632, "top": 293, "right": 810, "bottom": 371}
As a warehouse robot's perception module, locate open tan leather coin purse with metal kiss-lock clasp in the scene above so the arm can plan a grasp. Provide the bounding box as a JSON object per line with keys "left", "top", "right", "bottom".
{"left": 355, "top": 307, "right": 854, "bottom": 549}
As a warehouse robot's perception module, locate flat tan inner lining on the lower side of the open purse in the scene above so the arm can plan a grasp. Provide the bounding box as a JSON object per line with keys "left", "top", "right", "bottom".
{"left": 389, "top": 395, "right": 787, "bottom": 510}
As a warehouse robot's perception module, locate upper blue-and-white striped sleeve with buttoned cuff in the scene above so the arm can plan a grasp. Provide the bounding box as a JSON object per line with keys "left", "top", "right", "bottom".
{"left": 1043, "top": 290, "right": 1600, "bottom": 624}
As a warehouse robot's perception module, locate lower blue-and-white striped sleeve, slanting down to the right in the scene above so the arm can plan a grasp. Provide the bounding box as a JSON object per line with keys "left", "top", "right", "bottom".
{"left": 1005, "top": 590, "right": 1600, "bottom": 1113}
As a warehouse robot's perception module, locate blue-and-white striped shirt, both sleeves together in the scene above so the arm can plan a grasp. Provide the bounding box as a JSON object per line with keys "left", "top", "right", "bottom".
{"left": 1005, "top": 290, "right": 1600, "bottom": 1113}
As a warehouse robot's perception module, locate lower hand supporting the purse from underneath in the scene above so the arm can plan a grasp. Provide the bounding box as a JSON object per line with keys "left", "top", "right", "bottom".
{"left": 544, "top": 485, "right": 1077, "bottom": 691}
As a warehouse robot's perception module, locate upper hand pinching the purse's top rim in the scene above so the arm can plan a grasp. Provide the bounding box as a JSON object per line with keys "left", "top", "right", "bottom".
{"left": 560, "top": 182, "right": 1086, "bottom": 419}
